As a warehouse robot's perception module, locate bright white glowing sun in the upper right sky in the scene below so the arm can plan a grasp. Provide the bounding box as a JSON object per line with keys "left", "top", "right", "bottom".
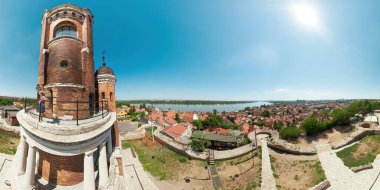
{"left": 292, "top": 4, "right": 319, "bottom": 29}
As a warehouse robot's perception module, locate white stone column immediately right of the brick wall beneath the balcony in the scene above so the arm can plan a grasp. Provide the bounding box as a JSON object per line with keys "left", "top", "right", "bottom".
{"left": 83, "top": 148, "right": 97, "bottom": 190}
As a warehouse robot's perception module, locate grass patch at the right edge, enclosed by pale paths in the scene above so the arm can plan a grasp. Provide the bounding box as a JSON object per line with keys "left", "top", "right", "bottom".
{"left": 336, "top": 135, "right": 380, "bottom": 168}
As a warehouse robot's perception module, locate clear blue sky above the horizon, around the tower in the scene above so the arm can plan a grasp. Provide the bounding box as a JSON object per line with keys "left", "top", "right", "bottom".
{"left": 0, "top": 0, "right": 380, "bottom": 100}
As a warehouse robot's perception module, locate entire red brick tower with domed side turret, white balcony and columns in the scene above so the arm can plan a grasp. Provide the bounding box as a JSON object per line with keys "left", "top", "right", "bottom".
{"left": 12, "top": 4, "right": 117, "bottom": 190}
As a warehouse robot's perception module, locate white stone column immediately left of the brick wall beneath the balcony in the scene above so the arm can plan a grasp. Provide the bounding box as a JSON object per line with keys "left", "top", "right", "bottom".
{"left": 25, "top": 145, "right": 37, "bottom": 189}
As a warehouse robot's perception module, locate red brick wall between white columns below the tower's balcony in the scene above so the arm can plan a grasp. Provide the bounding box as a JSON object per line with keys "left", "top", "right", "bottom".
{"left": 38, "top": 150, "right": 84, "bottom": 186}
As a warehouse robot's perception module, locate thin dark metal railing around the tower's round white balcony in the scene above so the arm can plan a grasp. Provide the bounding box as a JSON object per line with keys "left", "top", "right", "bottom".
{"left": 24, "top": 97, "right": 109, "bottom": 126}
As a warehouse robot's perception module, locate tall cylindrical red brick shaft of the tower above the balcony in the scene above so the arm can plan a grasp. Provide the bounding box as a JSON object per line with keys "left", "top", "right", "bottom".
{"left": 38, "top": 5, "right": 95, "bottom": 119}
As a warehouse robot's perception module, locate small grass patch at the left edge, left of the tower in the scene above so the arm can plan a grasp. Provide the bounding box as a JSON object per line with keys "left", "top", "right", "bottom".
{"left": 0, "top": 129, "right": 20, "bottom": 155}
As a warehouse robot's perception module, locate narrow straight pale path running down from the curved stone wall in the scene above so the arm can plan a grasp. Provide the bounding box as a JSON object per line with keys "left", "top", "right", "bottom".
{"left": 258, "top": 137, "right": 277, "bottom": 190}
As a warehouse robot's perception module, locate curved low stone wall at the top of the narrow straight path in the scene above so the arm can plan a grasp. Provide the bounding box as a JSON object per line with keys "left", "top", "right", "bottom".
{"left": 248, "top": 129, "right": 317, "bottom": 155}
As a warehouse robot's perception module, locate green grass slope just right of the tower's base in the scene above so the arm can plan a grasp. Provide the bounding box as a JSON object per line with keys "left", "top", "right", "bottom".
{"left": 122, "top": 140, "right": 193, "bottom": 180}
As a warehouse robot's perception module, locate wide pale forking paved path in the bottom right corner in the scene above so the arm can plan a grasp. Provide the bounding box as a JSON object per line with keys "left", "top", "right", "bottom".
{"left": 317, "top": 144, "right": 380, "bottom": 190}
